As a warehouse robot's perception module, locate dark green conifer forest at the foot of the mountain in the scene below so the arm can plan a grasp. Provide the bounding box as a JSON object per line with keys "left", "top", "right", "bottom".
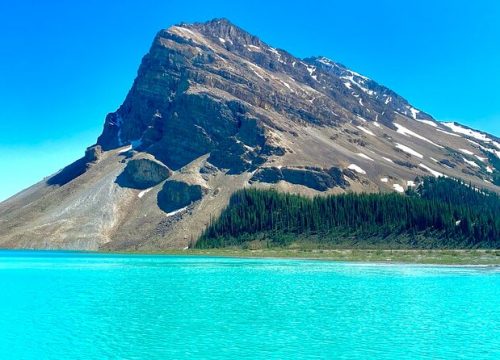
{"left": 196, "top": 178, "right": 500, "bottom": 249}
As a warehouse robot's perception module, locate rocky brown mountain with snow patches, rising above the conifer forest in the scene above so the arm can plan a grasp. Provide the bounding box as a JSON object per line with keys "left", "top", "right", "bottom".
{"left": 0, "top": 19, "right": 500, "bottom": 250}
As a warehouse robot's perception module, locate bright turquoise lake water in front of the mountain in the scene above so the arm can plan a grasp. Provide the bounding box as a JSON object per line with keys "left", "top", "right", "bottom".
{"left": 0, "top": 251, "right": 500, "bottom": 359}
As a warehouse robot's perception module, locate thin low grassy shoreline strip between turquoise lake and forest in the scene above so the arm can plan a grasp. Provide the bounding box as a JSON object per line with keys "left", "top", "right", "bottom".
{"left": 0, "top": 248, "right": 500, "bottom": 267}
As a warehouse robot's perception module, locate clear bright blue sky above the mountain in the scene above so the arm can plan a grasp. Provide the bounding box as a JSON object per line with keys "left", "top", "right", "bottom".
{"left": 0, "top": 0, "right": 500, "bottom": 200}
